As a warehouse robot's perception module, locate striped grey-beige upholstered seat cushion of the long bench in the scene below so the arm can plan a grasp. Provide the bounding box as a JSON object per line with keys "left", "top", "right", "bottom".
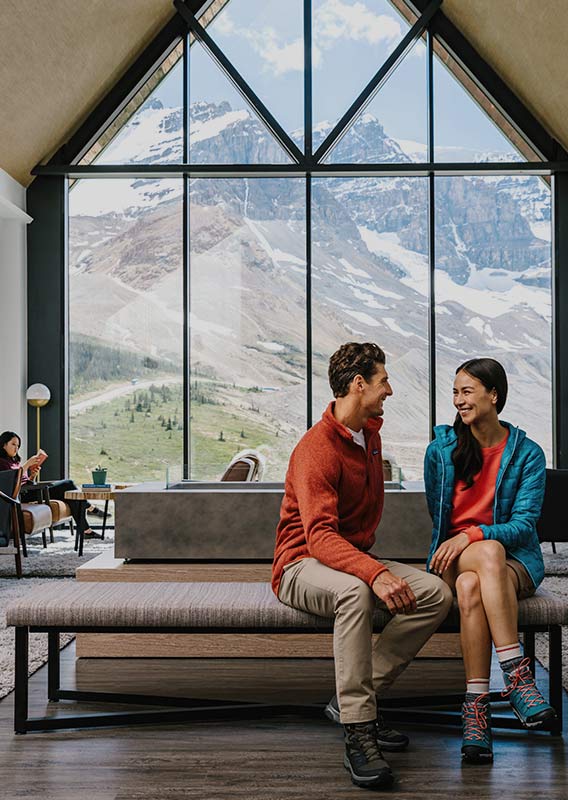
{"left": 6, "top": 582, "right": 568, "bottom": 632}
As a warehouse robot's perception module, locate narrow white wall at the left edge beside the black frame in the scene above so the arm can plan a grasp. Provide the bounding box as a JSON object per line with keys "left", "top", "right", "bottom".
{"left": 0, "top": 169, "right": 31, "bottom": 453}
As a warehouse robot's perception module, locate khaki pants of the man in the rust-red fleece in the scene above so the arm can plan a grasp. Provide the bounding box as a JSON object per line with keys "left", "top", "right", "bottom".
{"left": 278, "top": 558, "right": 452, "bottom": 724}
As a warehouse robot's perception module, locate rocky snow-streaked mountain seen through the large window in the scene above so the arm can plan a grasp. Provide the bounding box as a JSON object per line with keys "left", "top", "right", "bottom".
{"left": 69, "top": 101, "right": 550, "bottom": 474}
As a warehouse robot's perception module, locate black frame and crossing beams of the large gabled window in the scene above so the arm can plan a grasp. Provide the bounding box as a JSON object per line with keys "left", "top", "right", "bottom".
{"left": 28, "top": 0, "right": 568, "bottom": 474}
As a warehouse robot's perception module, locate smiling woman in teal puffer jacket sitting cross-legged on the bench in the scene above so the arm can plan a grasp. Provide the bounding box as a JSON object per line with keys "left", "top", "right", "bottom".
{"left": 424, "top": 358, "right": 555, "bottom": 762}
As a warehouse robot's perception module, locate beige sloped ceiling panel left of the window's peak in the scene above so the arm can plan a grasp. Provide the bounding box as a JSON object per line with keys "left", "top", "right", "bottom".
{"left": 0, "top": 0, "right": 174, "bottom": 186}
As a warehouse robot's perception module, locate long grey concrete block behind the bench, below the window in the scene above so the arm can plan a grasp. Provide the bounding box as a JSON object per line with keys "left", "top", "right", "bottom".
{"left": 115, "top": 482, "right": 432, "bottom": 562}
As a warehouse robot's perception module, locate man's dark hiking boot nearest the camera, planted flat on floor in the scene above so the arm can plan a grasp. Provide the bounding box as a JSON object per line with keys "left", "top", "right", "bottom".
{"left": 343, "top": 722, "right": 394, "bottom": 789}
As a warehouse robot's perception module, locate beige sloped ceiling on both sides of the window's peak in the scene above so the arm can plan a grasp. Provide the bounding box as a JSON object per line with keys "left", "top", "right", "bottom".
{"left": 0, "top": 0, "right": 568, "bottom": 186}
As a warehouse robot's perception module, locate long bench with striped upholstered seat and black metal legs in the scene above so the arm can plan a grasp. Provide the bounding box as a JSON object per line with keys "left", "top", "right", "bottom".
{"left": 6, "top": 582, "right": 568, "bottom": 734}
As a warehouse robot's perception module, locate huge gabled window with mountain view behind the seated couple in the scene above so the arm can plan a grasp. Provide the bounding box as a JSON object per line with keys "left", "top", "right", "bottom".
{"left": 65, "top": 0, "right": 552, "bottom": 480}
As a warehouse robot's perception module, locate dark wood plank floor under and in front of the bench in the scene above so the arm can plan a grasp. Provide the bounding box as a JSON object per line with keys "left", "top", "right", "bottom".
{"left": 0, "top": 645, "right": 568, "bottom": 800}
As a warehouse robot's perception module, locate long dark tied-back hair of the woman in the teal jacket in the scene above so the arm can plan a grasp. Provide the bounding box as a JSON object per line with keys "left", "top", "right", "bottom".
{"left": 452, "top": 358, "right": 508, "bottom": 489}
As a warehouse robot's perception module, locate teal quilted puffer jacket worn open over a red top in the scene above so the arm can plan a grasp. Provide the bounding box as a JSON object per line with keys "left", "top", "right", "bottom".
{"left": 424, "top": 422, "right": 546, "bottom": 587}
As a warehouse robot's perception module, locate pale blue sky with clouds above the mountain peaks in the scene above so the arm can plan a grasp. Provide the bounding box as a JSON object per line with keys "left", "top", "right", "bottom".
{"left": 156, "top": 0, "right": 513, "bottom": 160}
